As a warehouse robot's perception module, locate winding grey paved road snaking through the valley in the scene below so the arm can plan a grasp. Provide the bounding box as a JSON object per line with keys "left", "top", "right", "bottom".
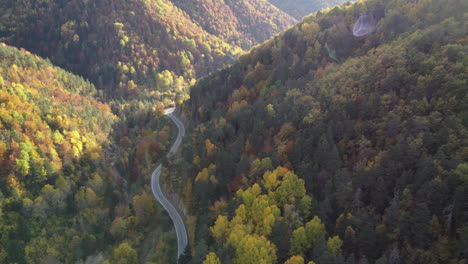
{"left": 151, "top": 108, "right": 188, "bottom": 257}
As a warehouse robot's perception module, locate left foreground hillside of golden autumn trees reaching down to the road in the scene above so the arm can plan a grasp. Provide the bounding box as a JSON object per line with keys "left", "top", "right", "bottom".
{"left": 0, "top": 44, "right": 181, "bottom": 263}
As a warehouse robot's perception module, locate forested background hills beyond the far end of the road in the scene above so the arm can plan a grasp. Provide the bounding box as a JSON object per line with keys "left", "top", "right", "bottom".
{"left": 0, "top": 0, "right": 294, "bottom": 101}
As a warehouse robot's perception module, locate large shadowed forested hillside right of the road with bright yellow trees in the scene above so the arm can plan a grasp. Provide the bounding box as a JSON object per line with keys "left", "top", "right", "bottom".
{"left": 165, "top": 0, "right": 468, "bottom": 264}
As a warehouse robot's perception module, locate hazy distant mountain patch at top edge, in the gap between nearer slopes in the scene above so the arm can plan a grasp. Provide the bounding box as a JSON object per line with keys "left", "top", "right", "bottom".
{"left": 268, "top": 0, "right": 354, "bottom": 20}
